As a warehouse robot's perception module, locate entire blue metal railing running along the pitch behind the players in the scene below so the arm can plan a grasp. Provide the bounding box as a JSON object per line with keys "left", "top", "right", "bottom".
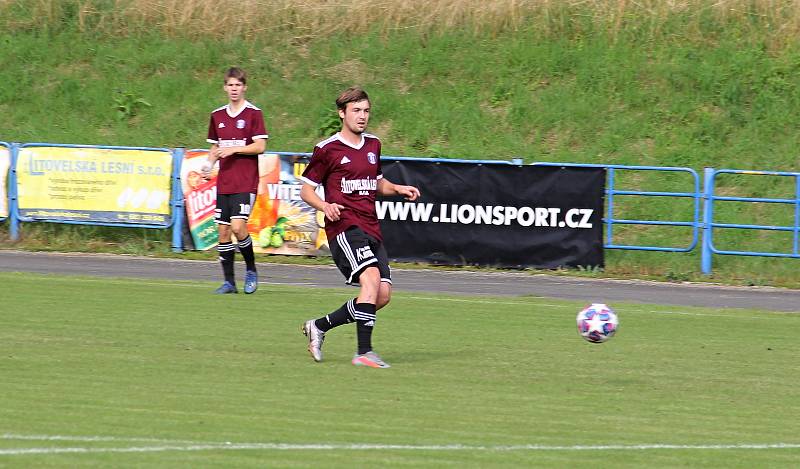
{"left": 6, "top": 142, "right": 800, "bottom": 274}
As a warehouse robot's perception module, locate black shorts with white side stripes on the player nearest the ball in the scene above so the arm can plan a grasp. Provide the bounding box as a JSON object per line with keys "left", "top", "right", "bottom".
{"left": 328, "top": 227, "right": 392, "bottom": 284}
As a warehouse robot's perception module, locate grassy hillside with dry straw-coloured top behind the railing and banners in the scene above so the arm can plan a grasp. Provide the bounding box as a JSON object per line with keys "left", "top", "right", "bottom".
{"left": 0, "top": 0, "right": 800, "bottom": 283}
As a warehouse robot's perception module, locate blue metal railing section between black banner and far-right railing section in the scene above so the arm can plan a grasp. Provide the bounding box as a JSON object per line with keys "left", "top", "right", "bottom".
{"left": 533, "top": 162, "right": 702, "bottom": 252}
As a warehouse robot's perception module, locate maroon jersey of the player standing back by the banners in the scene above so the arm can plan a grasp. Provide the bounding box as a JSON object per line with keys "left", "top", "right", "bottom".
{"left": 208, "top": 101, "right": 269, "bottom": 194}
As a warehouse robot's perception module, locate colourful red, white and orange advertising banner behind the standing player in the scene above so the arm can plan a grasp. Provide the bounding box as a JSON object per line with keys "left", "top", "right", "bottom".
{"left": 181, "top": 150, "right": 330, "bottom": 256}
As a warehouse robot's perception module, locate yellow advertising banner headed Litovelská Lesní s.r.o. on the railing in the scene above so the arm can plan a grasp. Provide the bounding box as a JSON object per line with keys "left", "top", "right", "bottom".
{"left": 16, "top": 146, "right": 172, "bottom": 226}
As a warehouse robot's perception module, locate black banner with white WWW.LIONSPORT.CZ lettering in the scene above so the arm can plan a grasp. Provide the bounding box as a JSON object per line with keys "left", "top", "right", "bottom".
{"left": 376, "top": 160, "right": 605, "bottom": 268}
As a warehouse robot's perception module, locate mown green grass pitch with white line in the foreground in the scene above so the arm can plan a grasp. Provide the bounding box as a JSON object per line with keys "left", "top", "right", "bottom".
{"left": 0, "top": 273, "right": 800, "bottom": 468}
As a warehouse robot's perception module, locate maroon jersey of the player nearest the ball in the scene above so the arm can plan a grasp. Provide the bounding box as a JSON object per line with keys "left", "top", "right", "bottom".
{"left": 300, "top": 133, "right": 383, "bottom": 240}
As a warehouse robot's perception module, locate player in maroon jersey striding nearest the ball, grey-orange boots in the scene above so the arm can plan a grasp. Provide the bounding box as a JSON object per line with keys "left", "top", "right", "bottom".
{"left": 300, "top": 88, "right": 420, "bottom": 368}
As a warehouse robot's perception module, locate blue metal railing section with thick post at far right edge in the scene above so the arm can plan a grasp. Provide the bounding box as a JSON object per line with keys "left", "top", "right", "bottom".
{"left": 701, "top": 168, "right": 800, "bottom": 275}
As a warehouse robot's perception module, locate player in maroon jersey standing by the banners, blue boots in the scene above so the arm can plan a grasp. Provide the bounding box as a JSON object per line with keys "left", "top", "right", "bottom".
{"left": 203, "top": 67, "right": 269, "bottom": 293}
